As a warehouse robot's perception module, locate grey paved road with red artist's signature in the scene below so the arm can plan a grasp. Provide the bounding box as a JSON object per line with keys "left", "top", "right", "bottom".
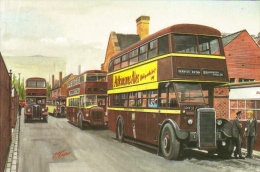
{"left": 18, "top": 115, "right": 260, "bottom": 172}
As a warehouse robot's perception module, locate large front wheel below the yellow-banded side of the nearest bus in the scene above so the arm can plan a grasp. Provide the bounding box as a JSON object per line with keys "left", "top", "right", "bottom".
{"left": 160, "top": 123, "right": 180, "bottom": 160}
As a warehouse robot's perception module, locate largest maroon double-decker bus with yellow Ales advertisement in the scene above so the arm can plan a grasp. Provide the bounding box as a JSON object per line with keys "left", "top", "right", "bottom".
{"left": 108, "top": 24, "right": 234, "bottom": 159}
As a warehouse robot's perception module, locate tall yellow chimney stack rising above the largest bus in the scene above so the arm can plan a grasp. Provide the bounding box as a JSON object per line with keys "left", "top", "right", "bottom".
{"left": 136, "top": 16, "right": 150, "bottom": 39}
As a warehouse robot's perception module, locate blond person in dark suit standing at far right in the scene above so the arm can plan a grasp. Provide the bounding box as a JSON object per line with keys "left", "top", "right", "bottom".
{"left": 244, "top": 110, "right": 258, "bottom": 158}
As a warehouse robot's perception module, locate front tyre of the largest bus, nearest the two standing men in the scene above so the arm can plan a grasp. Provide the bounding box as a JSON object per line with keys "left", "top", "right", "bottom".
{"left": 217, "top": 138, "right": 234, "bottom": 159}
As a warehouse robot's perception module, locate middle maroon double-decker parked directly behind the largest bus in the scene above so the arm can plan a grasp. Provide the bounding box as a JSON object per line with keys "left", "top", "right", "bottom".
{"left": 66, "top": 70, "right": 107, "bottom": 129}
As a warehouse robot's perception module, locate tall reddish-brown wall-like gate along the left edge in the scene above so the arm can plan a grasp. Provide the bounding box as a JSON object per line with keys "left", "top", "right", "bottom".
{"left": 0, "top": 52, "right": 12, "bottom": 171}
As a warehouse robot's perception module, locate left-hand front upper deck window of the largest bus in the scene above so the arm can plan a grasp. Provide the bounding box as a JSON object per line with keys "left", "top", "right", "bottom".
{"left": 174, "top": 34, "right": 198, "bottom": 53}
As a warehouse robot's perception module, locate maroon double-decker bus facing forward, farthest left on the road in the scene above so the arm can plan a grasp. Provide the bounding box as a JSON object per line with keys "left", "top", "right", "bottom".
{"left": 24, "top": 77, "right": 48, "bottom": 123}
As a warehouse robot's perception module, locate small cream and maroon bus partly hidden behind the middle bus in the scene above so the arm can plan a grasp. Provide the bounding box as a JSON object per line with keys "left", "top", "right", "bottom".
{"left": 47, "top": 96, "right": 66, "bottom": 117}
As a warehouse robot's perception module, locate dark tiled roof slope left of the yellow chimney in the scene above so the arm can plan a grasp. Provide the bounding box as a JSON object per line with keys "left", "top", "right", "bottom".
{"left": 116, "top": 34, "right": 140, "bottom": 51}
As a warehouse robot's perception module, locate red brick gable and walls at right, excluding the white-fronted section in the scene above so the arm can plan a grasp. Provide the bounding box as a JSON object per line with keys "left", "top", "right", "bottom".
{"left": 214, "top": 30, "right": 260, "bottom": 119}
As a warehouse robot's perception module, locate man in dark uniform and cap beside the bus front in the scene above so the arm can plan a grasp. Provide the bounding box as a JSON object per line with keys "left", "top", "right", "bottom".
{"left": 232, "top": 111, "right": 244, "bottom": 159}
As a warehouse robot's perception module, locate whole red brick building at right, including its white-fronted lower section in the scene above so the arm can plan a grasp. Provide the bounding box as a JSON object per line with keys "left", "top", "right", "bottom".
{"left": 214, "top": 30, "right": 260, "bottom": 150}
